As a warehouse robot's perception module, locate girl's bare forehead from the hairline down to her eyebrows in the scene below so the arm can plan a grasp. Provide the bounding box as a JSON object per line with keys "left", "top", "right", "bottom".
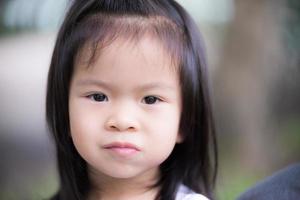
{"left": 73, "top": 36, "right": 178, "bottom": 86}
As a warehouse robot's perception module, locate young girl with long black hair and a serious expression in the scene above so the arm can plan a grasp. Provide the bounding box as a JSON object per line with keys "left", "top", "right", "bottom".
{"left": 46, "top": 0, "right": 216, "bottom": 200}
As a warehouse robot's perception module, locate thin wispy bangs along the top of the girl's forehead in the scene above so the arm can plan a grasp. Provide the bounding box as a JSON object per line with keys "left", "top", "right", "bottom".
{"left": 70, "top": 13, "right": 185, "bottom": 70}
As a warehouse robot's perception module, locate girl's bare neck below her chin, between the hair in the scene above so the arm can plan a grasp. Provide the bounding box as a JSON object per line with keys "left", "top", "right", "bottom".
{"left": 88, "top": 168, "right": 159, "bottom": 200}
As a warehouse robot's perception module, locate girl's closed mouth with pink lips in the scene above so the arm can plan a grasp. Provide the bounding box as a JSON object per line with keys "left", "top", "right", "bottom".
{"left": 103, "top": 142, "right": 140, "bottom": 156}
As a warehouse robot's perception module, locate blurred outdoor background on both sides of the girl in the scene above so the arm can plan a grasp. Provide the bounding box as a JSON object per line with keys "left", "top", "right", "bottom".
{"left": 0, "top": 0, "right": 300, "bottom": 200}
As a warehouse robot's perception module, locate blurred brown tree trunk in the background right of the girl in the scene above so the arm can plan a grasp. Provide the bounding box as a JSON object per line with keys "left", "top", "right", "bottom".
{"left": 214, "top": 0, "right": 282, "bottom": 171}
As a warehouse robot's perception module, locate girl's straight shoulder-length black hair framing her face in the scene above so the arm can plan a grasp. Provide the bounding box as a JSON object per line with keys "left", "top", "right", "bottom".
{"left": 46, "top": 0, "right": 217, "bottom": 200}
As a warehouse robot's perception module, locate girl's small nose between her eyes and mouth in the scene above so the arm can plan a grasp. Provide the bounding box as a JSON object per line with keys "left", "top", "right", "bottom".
{"left": 105, "top": 106, "right": 139, "bottom": 132}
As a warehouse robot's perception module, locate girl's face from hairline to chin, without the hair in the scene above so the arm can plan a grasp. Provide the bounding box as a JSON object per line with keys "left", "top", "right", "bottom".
{"left": 69, "top": 37, "right": 181, "bottom": 181}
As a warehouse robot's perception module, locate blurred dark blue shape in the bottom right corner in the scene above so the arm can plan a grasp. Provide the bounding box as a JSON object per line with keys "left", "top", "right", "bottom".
{"left": 238, "top": 163, "right": 300, "bottom": 200}
